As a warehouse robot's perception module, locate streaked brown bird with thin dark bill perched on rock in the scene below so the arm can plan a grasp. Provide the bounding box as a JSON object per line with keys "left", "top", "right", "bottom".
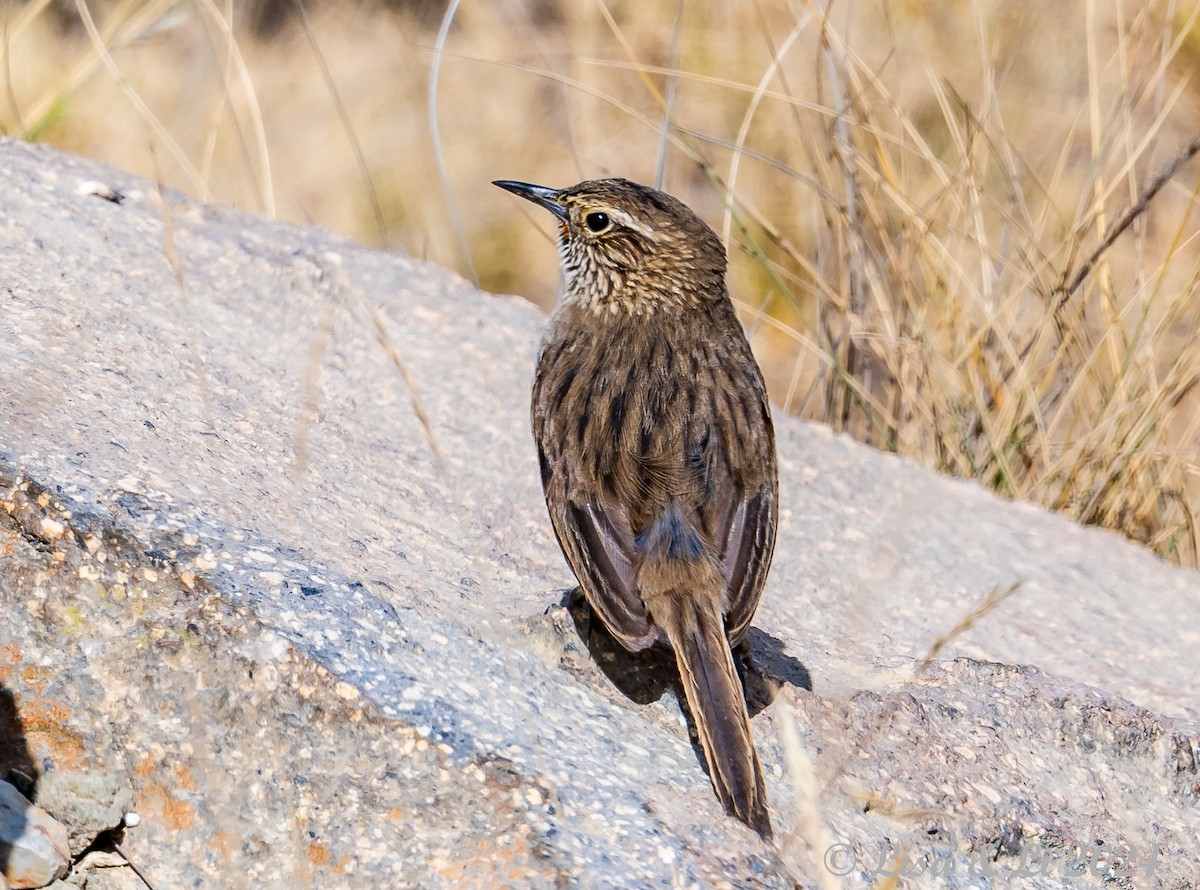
{"left": 494, "top": 179, "right": 779, "bottom": 836}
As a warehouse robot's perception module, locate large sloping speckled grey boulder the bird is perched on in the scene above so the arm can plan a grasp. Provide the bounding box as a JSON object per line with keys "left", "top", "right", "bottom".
{"left": 0, "top": 140, "right": 1200, "bottom": 889}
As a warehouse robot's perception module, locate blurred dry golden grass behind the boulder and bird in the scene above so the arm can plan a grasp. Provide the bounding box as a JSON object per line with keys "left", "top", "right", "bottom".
{"left": 0, "top": 0, "right": 1200, "bottom": 565}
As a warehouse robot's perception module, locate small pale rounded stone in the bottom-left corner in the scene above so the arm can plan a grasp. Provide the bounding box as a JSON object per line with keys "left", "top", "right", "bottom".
{"left": 0, "top": 782, "right": 71, "bottom": 890}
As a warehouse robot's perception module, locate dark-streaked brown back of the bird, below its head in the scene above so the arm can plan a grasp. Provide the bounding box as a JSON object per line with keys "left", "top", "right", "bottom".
{"left": 532, "top": 294, "right": 776, "bottom": 636}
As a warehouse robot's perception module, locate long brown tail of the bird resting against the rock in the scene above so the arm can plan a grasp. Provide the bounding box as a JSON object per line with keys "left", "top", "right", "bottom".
{"left": 654, "top": 591, "right": 772, "bottom": 837}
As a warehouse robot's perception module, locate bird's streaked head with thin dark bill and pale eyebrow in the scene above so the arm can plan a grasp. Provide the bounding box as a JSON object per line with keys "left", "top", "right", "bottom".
{"left": 493, "top": 179, "right": 725, "bottom": 315}
